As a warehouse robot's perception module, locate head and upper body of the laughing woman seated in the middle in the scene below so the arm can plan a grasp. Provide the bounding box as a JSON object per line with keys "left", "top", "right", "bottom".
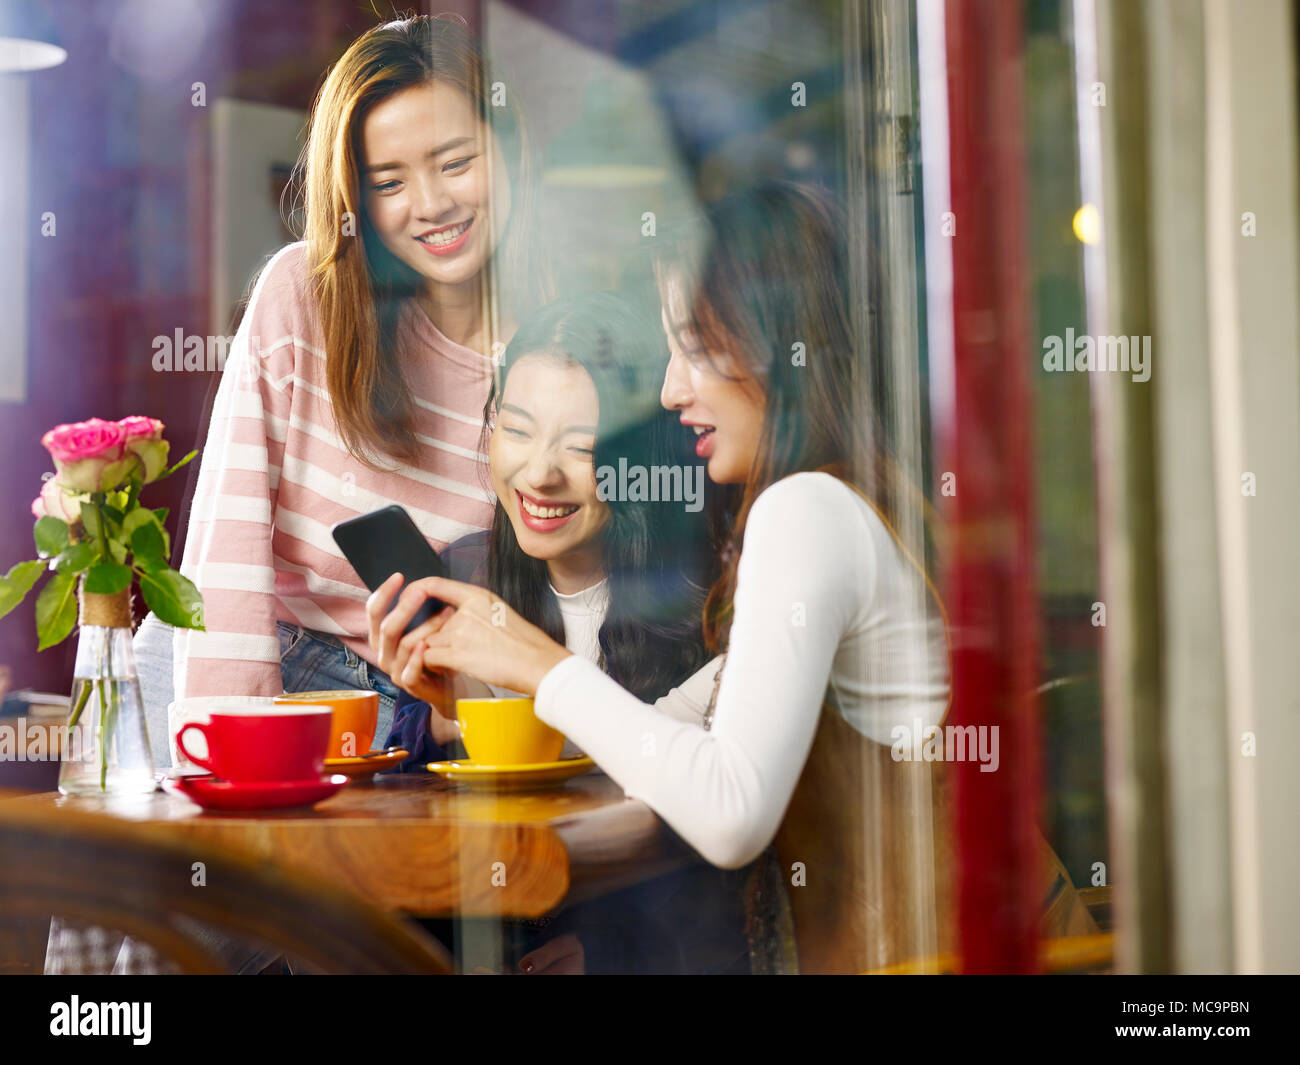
{"left": 390, "top": 293, "right": 714, "bottom": 767}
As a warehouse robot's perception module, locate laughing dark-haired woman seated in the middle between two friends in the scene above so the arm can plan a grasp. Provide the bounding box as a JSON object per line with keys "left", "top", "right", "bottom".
{"left": 387, "top": 293, "right": 745, "bottom": 973}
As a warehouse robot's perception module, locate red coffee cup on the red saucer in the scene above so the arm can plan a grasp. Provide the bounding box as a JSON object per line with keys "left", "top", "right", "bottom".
{"left": 176, "top": 706, "right": 333, "bottom": 783}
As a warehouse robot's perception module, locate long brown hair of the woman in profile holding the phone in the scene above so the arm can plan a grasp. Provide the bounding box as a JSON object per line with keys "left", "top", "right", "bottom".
{"left": 655, "top": 182, "right": 907, "bottom": 650}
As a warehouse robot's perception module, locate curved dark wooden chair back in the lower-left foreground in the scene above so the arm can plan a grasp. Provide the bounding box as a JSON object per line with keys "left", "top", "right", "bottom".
{"left": 0, "top": 800, "right": 452, "bottom": 974}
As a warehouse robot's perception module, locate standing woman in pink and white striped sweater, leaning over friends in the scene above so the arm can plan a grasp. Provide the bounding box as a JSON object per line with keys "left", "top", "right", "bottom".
{"left": 137, "top": 17, "right": 546, "bottom": 761}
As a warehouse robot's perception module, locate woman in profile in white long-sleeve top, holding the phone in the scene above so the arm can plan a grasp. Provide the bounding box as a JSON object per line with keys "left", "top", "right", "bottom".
{"left": 369, "top": 185, "right": 949, "bottom": 964}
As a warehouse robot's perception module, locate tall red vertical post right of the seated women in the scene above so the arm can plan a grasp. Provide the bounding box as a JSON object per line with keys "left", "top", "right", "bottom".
{"left": 940, "top": 0, "right": 1040, "bottom": 973}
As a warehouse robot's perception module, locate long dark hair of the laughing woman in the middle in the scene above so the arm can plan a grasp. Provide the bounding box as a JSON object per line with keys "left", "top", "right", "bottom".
{"left": 485, "top": 293, "right": 715, "bottom": 701}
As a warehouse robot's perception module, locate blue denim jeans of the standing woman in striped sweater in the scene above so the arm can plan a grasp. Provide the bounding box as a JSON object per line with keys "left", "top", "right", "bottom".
{"left": 134, "top": 614, "right": 399, "bottom": 769}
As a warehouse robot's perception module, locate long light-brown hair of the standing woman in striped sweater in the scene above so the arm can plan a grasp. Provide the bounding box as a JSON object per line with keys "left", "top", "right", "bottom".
{"left": 298, "top": 16, "right": 547, "bottom": 467}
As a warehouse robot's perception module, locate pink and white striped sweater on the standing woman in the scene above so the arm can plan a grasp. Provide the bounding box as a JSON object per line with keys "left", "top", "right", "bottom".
{"left": 174, "top": 243, "right": 494, "bottom": 698}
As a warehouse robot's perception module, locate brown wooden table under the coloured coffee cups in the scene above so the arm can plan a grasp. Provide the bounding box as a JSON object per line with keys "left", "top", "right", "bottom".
{"left": 9, "top": 772, "right": 698, "bottom": 917}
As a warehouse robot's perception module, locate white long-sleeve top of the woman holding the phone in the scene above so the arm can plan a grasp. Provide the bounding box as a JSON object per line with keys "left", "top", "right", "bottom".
{"left": 534, "top": 473, "right": 949, "bottom": 869}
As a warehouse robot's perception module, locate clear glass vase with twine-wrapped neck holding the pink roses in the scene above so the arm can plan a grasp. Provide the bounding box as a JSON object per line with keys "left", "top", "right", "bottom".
{"left": 59, "top": 589, "right": 156, "bottom": 795}
